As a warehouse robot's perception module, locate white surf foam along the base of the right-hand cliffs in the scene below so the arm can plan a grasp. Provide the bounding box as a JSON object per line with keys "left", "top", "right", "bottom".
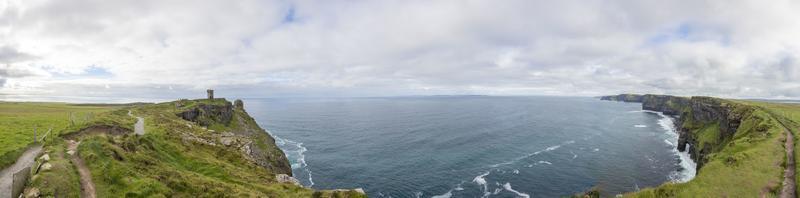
{"left": 644, "top": 111, "right": 697, "bottom": 183}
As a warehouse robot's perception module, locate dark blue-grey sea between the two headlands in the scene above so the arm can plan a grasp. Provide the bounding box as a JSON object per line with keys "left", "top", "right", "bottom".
{"left": 245, "top": 96, "right": 693, "bottom": 197}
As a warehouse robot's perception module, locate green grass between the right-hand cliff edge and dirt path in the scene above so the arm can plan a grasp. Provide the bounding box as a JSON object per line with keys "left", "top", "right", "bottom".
{"left": 625, "top": 101, "right": 784, "bottom": 197}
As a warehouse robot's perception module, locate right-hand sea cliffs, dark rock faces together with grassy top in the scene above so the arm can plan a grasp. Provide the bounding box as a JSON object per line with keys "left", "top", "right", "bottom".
{"left": 601, "top": 94, "right": 785, "bottom": 197}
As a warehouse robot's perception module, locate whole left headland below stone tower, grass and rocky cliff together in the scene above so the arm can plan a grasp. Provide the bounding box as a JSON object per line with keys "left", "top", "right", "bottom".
{"left": 3, "top": 99, "right": 365, "bottom": 197}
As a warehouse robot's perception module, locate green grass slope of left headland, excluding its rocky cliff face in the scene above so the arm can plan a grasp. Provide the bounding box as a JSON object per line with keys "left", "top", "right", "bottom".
{"left": 25, "top": 100, "right": 372, "bottom": 197}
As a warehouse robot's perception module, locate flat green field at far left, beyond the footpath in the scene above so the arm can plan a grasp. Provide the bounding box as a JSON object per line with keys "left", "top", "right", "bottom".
{"left": 0, "top": 102, "right": 111, "bottom": 167}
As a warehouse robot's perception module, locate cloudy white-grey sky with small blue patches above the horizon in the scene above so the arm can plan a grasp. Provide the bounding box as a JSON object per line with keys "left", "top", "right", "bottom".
{"left": 0, "top": 0, "right": 800, "bottom": 100}
